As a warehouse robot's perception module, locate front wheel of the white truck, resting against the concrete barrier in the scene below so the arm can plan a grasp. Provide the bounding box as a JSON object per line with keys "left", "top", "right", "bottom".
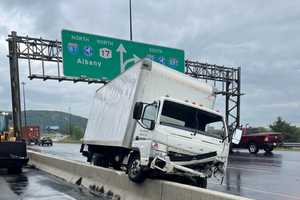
{"left": 127, "top": 153, "right": 146, "bottom": 183}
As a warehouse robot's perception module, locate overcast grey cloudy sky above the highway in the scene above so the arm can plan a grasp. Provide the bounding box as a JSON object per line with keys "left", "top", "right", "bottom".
{"left": 0, "top": 0, "right": 300, "bottom": 126}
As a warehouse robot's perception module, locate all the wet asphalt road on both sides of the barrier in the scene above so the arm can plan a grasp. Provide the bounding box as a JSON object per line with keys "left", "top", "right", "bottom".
{"left": 0, "top": 144, "right": 300, "bottom": 200}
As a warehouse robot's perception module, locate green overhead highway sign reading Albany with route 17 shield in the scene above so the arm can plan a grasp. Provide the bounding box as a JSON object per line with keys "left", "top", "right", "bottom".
{"left": 61, "top": 30, "right": 184, "bottom": 80}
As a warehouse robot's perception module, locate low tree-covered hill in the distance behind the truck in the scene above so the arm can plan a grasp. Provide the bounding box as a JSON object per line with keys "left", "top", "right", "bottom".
{"left": 22, "top": 110, "right": 87, "bottom": 132}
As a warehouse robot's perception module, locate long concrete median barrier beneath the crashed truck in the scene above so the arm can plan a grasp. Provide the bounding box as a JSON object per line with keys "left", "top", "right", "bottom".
{"left": 28, "top": 151, "right": 252, "bottom": 200}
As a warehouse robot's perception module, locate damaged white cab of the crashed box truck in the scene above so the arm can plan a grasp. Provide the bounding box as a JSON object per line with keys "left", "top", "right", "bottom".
{"left": 129, "top": 97, "right": 229, "bottom": 185}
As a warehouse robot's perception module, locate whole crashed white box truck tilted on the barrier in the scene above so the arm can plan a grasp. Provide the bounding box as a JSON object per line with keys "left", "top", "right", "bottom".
{"left": 80, "top": 60, "right": 241, "bottom": 188}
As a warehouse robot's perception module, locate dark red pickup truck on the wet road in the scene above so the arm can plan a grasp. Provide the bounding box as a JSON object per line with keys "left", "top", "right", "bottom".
{"left": 232, "top": 128, "right": 283, "bottom": 154}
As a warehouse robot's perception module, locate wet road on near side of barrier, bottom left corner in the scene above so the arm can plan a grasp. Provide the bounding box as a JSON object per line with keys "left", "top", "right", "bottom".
{"left": 0, "top": 168, "right": 99, "bottom": 200}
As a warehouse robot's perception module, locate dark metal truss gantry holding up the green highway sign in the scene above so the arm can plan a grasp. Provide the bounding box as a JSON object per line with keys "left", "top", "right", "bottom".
{"left": 7, "top": 31, "right": 241, "bottom": 138}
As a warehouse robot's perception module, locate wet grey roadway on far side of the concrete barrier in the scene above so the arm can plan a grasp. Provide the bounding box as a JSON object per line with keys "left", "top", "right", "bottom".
{"left": 29, "top": 144, "right": 300, "bottom": 200}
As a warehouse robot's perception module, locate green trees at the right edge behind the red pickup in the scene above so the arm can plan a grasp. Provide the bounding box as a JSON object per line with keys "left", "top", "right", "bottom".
{"left": 270, "top": 117, "right": 300, "bottom": 142}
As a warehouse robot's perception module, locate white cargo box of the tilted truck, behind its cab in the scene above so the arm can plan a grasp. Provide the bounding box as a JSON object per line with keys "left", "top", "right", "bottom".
{"left": 83, "top": 60, "right": 215, "bottom": 147}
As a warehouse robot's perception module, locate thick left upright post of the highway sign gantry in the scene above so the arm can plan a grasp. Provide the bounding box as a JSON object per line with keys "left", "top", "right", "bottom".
{"left": 8, "top": 31, "right": 22, "bottom": 139}
